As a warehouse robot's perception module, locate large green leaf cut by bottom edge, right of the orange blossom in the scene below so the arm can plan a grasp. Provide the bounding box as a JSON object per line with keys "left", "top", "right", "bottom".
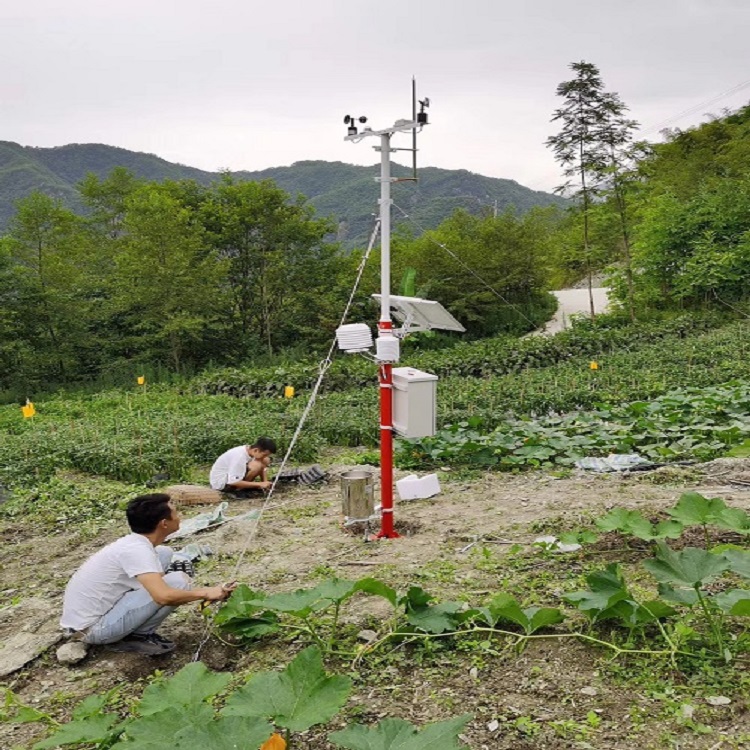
{"left": 328, "top": 714, "right": 471, "bottom": 750}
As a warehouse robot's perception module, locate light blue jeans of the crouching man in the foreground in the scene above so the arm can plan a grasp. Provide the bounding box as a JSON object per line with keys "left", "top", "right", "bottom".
{"left": 83, "top": 546, "right": 193, "bottom": 645}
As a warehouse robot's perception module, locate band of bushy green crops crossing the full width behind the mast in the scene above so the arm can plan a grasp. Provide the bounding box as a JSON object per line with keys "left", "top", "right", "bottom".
{"left": 0, "top": 323, "right": 750, "bottom": 486}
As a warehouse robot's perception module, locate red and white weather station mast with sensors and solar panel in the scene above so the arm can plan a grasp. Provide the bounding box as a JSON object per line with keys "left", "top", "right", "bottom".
{"left": 337, "top": 79, "right": 465, "bottom": 539}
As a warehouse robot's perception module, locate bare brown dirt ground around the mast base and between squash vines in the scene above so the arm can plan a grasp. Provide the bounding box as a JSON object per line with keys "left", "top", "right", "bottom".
{"left": 0, "top": 459, "right": 750, "bottom": 750}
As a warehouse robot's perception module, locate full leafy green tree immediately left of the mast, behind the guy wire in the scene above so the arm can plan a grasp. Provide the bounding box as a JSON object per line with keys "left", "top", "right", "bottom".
{"left": 201, "top": 176, "right": 351, "bottom": 356}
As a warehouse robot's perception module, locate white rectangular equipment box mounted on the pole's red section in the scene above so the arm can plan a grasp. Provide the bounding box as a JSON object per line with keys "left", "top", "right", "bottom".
{"left": 393, "top": 367, "right": 438, "bottom": 437}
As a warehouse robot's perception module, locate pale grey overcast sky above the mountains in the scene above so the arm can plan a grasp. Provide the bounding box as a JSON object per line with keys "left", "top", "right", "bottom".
{"left": 0, "top": 0, "right": 750, "bottom": 190}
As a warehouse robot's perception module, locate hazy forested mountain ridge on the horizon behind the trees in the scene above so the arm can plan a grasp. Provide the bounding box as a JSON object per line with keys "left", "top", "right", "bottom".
{"left": 0, "top": 141, "right": 567, "bottom": 247}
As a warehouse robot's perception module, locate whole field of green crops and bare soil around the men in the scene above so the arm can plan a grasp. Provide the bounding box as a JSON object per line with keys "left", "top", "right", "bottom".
{"left": 0, "top": 318, "right": 750, "bottom": 750}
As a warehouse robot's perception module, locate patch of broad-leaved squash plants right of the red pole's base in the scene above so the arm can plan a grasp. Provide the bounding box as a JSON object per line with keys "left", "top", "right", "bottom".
{"left": 397, "top": 381, "right": 750, "bottom": 469}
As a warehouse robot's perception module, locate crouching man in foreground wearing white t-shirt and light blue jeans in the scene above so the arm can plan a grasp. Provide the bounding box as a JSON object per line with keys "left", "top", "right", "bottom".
{"left": 60, "top": 493, "right": 233, "bottom": 656}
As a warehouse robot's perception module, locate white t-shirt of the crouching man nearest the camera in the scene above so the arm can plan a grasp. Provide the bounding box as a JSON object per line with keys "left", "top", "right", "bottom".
{"left": 60, "top": 534, "right": 164, "bottom": 630}
